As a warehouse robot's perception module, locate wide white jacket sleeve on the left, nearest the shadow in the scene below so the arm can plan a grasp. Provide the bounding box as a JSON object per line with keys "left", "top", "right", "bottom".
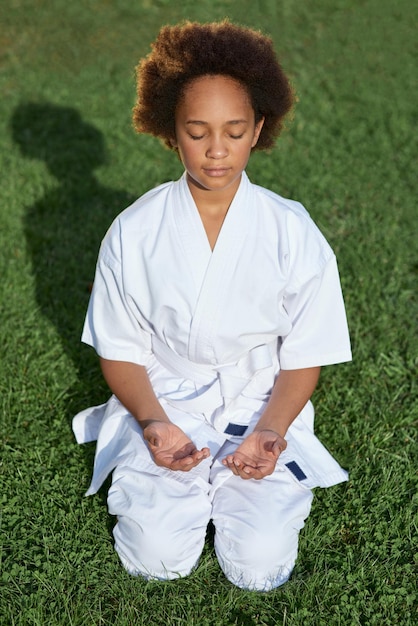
{"left": 81, "top": 220, "right": 151, "bottom": 365}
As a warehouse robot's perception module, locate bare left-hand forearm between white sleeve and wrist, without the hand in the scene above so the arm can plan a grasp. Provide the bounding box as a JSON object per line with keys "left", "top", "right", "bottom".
{"left": 100, "top": 358, "right": 169, "bottom": 428}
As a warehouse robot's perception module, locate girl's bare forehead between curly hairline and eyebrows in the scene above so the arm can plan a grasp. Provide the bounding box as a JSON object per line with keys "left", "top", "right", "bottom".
{"left": 179, "top": 75, "right": 252, "bottom": 113}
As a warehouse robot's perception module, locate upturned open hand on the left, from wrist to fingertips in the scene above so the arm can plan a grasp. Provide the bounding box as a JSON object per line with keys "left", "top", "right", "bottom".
{"left": 143, "top": 421, "right": 210, "bottom": 472}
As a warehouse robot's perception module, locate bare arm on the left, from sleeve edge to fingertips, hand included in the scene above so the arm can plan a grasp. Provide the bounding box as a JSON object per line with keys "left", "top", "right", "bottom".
{"left": 100, "top": 358, "right": 209, "bottom": 471}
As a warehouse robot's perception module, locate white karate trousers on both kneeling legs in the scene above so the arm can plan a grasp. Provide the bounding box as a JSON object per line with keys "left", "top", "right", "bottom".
{"left": 108, "top": 434, "right": 312, "bottom": 591}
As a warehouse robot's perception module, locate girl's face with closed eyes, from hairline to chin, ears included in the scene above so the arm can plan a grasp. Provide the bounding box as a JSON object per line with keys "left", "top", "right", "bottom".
{"left": 173, "top": 75, "right": 264, "bottom": 201}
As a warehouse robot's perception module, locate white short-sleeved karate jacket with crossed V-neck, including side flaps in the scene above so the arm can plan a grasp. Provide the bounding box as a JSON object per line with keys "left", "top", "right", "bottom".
{"left": 74, "top": 173, "right": 351, "bottom": 487}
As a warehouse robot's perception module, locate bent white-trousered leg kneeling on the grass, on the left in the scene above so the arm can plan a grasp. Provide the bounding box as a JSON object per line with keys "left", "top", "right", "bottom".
{"left": 108, "top": 466, "right": 211, "bottom": 580}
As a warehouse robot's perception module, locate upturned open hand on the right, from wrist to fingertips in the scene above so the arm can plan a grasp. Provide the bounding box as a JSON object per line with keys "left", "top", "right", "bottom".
{"left": 222, "top": 430, "right": 287, "bottom": 480}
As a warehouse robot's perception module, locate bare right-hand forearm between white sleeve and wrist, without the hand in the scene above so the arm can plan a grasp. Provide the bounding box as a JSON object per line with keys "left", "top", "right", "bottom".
{"left": 255, "top": 367, "right": 321, "bottom": 437}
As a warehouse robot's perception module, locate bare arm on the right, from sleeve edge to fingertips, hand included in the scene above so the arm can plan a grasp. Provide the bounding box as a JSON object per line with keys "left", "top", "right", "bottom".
{"left": 223, "top": 367, "right": 321, "bottom": 479}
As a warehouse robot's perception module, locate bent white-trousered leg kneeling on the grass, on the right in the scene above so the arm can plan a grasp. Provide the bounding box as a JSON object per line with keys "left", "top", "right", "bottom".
{"left": 213, "top": 468, "right": 313, "bottom": 591}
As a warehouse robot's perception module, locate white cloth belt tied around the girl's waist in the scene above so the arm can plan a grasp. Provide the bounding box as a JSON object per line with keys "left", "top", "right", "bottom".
{"left": 152, "top": 335, "right": 277, "bottom": 413}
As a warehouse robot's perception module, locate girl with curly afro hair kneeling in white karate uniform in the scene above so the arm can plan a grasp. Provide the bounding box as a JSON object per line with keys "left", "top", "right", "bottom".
{"left": 74, "top": 21, "right": 351, "bottom": 591}
